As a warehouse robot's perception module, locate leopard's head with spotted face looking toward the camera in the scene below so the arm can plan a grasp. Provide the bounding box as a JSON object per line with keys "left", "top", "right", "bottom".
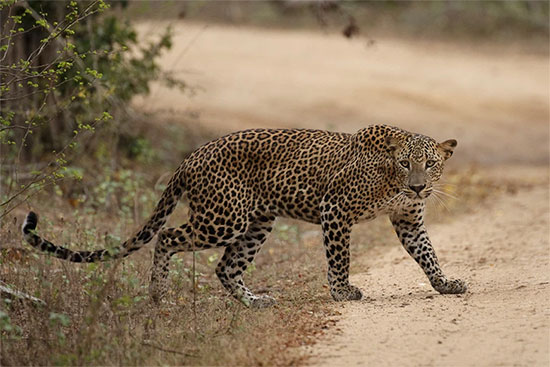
{"left": 386, "top": 135, "right": 457, "bottom": 200}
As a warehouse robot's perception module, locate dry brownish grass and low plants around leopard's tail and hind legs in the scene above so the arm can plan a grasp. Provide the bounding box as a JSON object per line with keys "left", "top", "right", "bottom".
{"left": 0, "top": 122, "right": 331, "bottom": 365}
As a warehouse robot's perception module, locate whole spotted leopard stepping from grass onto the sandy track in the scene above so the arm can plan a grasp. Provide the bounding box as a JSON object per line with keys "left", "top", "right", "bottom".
{"left": 22, "top": 125, "right": 467, "bottom": 308}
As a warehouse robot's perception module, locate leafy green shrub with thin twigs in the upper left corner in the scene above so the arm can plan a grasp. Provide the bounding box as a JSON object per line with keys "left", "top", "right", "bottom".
{"left": 0, "top": 0, "right": 184, "bottom": 219}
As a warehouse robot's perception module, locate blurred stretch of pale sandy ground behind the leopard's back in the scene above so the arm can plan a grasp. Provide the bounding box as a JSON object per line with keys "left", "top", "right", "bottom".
{"left": 136, "top": 22, "right": 550, "bottom": 164}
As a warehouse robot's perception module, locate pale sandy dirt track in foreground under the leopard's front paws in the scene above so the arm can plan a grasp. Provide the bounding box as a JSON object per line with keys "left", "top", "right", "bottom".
{"left": 308, "top": 182, "right": 550, "bottom": 366}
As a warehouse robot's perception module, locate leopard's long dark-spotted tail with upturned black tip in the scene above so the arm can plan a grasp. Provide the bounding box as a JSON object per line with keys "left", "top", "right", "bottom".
{"left": 21, "top": 170, "right": 183, "bottom": 263}
